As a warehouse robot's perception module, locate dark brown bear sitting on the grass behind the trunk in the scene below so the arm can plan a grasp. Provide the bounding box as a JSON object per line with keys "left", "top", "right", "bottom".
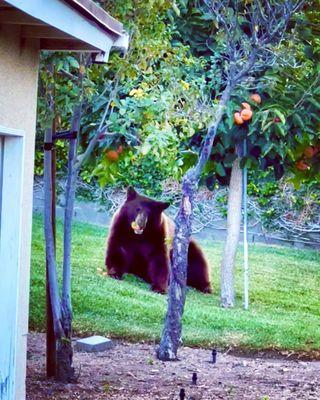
{"left": 106, "top": 187, "right": 212, "bottom": 293}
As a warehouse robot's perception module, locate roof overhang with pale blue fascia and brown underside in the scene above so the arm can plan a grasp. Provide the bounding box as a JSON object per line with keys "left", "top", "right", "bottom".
{"left": 0, "top": 0, "right": 129, "bottom": 62}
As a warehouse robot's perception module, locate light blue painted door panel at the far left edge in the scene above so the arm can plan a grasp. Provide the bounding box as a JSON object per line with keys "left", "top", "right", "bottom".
{"left": 0, "top": 127, "right": 23, "bottom": 400}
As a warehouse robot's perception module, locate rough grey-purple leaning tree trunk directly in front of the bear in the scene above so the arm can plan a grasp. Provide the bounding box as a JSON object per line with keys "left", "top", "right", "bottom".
{"left": 157, "top": 84, "right": 232, "bottom": 361}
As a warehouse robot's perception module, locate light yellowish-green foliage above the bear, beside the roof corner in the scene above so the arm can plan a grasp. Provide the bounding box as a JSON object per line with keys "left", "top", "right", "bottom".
{"left": 36, "top": 0, "right": 212, "bottom": 190}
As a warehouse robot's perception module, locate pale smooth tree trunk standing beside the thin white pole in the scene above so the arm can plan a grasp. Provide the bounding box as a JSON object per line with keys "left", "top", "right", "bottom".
{"left": 221, "top": 158, "right": 242, "bottom": 308}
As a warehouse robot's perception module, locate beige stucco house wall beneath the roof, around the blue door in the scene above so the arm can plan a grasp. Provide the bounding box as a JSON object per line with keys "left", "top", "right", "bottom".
{"left": 0, "top": 25, "right": 39, "bottom": 400}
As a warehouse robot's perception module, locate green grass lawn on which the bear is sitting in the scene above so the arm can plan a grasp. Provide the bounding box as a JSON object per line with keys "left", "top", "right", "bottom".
{"left": 30, "top": 216, "right": 320, "bottom": 351}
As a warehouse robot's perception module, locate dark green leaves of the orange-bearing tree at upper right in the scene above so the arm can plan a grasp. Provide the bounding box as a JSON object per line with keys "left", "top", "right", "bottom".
{"left": 171, "top": 0, "right": 320, "bottom": 188}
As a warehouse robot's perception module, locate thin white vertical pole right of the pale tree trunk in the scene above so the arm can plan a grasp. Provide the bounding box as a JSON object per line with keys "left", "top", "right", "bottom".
{"left": 243, "top": 139, "right": 249, "bottom": 310}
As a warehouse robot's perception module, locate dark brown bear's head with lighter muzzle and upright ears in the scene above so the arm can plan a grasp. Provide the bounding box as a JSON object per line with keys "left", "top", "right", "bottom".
{"left": 121, "top": 186, "right": 170, "bottom": 235}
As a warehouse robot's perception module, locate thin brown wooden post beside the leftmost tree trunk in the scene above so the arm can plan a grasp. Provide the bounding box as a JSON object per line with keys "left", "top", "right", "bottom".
{"left": 46, "top": 119, "right": 57, "bottom": 378}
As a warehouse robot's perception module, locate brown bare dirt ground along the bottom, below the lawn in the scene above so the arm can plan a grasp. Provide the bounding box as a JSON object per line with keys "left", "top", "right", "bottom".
{"left": 27, "top": 334, "right": 320, "bottom": 400}
